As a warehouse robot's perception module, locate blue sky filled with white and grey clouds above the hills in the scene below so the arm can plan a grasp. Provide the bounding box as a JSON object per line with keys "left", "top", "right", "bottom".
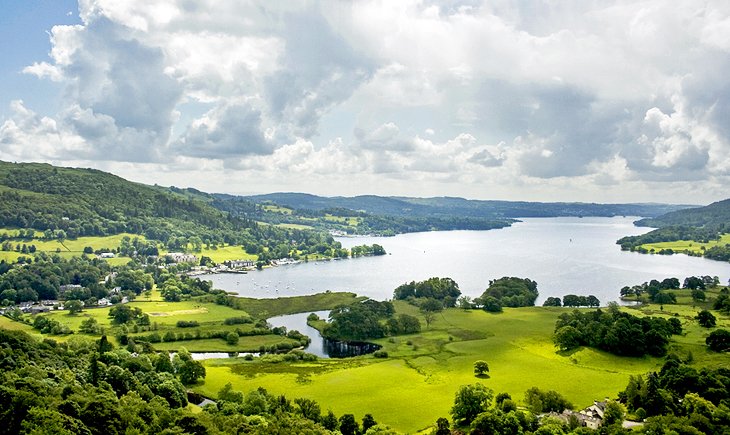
{"left": 0, "top": 0, "right": 730, "bottom": 204}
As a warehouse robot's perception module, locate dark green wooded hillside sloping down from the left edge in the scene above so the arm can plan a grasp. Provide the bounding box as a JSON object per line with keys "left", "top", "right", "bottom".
{"left": 0, "top": 162, "right": 331, "bottom": 252}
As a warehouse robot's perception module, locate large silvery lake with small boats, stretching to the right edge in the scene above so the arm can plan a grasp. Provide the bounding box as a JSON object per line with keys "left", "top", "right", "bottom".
{"left": 201, "top": 217, "right": 730, "bottom": 305}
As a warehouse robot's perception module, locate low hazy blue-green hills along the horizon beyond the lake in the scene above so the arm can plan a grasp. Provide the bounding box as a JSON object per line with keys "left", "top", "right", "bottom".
{"left": 241, "top": 193, "right": 692, "bottom": 219}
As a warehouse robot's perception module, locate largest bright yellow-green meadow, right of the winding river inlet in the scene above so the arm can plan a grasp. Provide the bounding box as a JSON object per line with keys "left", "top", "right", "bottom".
{"left": 198, "top": 302, "right": 702, "bottom": 432}
